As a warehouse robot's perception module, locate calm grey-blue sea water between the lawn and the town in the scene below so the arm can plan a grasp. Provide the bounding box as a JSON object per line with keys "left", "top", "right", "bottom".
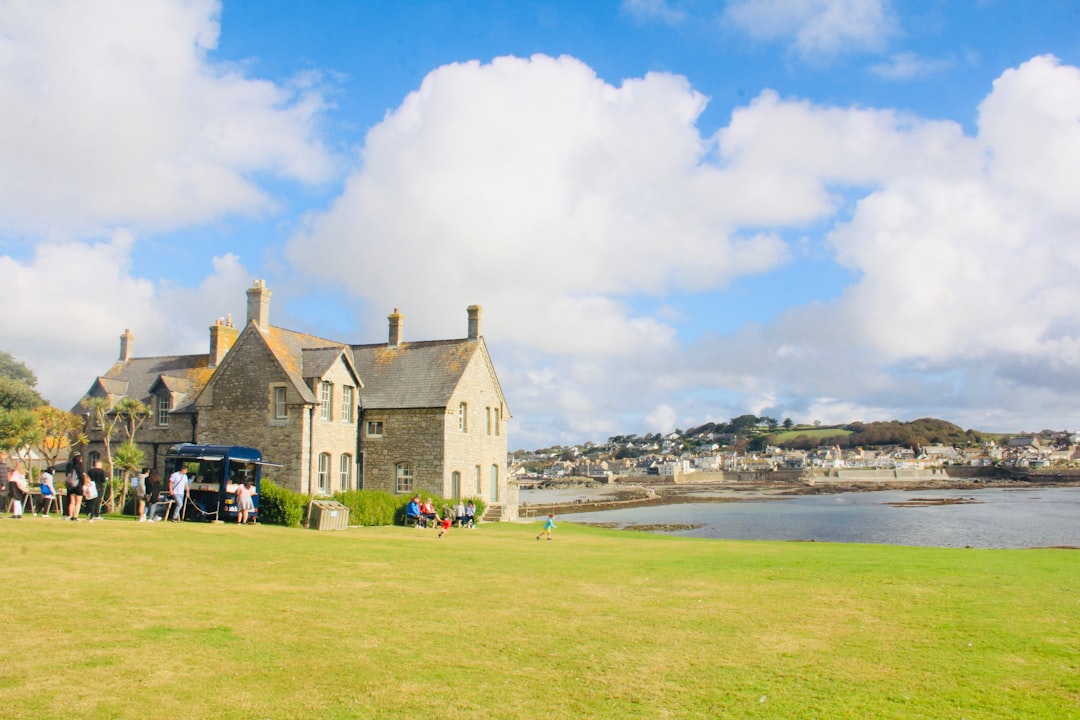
{"left": 522, "top": 487, "right": 1080, "bottom": 547}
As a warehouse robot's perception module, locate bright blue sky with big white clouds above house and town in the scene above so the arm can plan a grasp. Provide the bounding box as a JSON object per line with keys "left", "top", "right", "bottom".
{"left": 0, "top": 0, "right": 1080, "bottom": 448}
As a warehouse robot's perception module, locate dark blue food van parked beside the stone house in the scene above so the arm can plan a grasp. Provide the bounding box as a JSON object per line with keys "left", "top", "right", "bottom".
{"left": 164, "top": 443, "right": 280, "bottom": 522}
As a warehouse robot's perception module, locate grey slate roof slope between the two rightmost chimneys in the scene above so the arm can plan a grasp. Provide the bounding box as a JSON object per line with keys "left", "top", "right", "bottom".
{"left": 352, "top": 340, "right": 480, "bottom": 409}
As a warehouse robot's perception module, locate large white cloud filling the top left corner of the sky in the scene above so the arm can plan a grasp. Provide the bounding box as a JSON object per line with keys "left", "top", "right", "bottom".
{"left": 0, "top": 0, "right": 334, "bottom": 237}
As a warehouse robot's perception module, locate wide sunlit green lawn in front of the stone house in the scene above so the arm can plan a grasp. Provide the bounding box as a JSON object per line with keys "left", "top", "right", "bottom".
{"left": 0, "top": 517, "right": 1080, "bottom": 720}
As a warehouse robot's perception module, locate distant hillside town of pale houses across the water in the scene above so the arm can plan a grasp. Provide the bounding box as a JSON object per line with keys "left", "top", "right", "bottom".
{"left": 511, "top": 416, "right": 1080, "bottom": 481}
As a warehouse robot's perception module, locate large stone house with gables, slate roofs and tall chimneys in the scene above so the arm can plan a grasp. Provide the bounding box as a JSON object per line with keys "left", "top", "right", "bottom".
{"left": 77, "top": 281, "right": 514, "bottom": 519}
